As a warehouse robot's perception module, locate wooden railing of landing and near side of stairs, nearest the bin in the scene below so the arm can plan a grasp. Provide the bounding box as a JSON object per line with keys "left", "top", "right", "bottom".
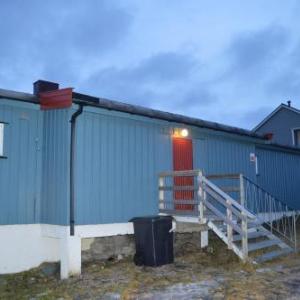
{"left": 159, "top": 170, "right": 256, "bottom": 260}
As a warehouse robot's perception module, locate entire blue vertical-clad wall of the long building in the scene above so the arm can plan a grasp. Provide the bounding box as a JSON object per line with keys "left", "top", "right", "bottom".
{"left": 0, "top": 100, "right": 300, "bottom": 225}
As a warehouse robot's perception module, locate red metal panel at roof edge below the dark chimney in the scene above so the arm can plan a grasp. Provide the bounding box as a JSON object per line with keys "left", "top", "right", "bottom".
{"left": 39, "top": 88, "right": 73, "bottom": 109}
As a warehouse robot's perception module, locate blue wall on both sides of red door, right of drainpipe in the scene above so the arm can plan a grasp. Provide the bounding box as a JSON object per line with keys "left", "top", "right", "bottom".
{"left": 76, "top": 108, "right": 255, "bottom": 224}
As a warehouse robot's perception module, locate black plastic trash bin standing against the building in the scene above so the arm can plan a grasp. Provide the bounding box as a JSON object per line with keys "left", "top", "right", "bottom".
{"left": 130, "top": 216, "right": 174, "bottom": 267}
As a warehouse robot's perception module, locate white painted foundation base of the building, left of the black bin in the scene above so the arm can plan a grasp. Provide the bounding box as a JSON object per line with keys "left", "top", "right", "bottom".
{"left": 0, "top": 223, "right": 133, "bottom": 278}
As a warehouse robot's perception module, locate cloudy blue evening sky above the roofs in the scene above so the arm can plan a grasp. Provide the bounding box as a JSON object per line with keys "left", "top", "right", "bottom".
{"left": 0, "top": 0, "right": 300, "bottom": 128}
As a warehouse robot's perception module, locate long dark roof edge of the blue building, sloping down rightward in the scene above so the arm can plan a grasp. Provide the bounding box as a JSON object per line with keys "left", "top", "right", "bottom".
{"left": 0, "top": 89, "right": 265, "bottom": 139}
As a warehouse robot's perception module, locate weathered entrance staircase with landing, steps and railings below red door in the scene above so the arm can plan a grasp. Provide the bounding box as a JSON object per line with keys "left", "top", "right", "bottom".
{"left": 159, "top": 170, "right": 298, "bottom": 263}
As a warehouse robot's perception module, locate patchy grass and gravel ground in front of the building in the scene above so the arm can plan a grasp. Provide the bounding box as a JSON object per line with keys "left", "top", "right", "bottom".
{"left": 0, "top": 239, "right": 300, "bottom": 300}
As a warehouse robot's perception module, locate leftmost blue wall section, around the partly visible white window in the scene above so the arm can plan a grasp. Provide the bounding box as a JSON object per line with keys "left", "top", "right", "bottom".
{"left": 0, "top": 100, "right": 42, "bottom": 224}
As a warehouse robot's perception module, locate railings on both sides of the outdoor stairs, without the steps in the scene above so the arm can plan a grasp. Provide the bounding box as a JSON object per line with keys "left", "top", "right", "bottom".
{"left": 158, "top": 170, "right": 299, "bottom": 260}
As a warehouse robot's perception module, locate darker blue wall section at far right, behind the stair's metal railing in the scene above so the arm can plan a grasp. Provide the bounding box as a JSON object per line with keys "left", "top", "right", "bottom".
{"left": 256, "top": 147, "right": 300, "bottom": 209}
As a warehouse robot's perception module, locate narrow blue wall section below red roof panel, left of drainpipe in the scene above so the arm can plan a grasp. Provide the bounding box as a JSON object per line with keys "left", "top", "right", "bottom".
{"left": 41, "top": 109, "right": 71, "bottom": 225}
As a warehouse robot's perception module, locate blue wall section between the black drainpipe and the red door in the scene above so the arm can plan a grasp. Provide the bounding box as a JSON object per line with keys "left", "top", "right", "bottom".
{"left": 75, "top": 110, "right": 172, "bottom": 224}
